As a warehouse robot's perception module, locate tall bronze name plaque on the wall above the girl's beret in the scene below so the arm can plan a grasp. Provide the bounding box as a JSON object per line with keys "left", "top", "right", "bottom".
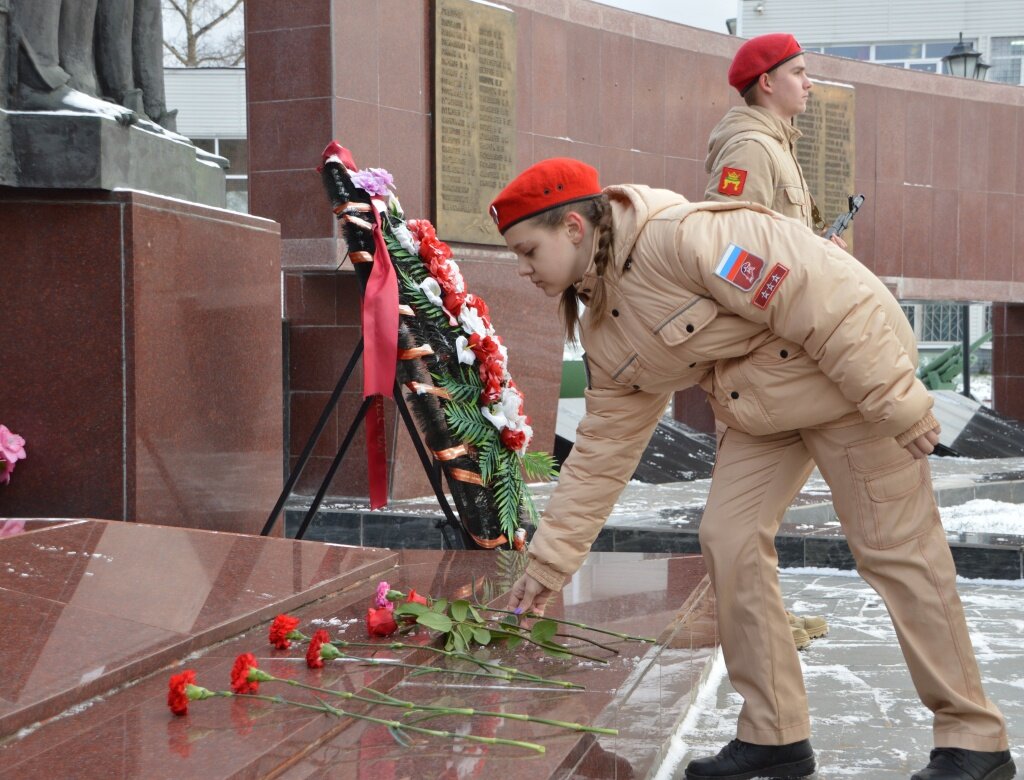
{"left": 434, "top": 0, "right": 516, "bottom": 245}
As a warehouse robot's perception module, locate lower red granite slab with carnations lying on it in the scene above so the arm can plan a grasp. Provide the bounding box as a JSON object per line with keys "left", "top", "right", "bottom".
{"left": 0, "top": 528, "right": 716, "bottom": 780}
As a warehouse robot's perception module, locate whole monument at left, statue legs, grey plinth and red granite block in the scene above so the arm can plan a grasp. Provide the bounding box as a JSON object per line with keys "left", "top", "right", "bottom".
{"left": 0, "top": 0, "right": 284, "bottom": 533}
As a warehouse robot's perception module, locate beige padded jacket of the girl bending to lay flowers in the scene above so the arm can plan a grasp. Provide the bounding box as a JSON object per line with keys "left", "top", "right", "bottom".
{"left": 527, "top": 185, "right": 936, "bottom": 590}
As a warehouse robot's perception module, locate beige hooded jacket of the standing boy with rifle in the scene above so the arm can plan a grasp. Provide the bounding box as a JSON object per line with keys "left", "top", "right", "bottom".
{"left": 705, "top": 105, "right": 815, "bottom": 229}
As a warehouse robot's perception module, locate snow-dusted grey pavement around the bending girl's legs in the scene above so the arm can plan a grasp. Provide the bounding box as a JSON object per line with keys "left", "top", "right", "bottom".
{"left": 656, "top": 569, "right": 1024, "bottom": 780}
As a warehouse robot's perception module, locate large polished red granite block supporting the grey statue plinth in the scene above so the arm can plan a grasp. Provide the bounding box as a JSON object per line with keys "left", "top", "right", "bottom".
{"left": 0, "top": 187, "right": 283, "bottom": 533}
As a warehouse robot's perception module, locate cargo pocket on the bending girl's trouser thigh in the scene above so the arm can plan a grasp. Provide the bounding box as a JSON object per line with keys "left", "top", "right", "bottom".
{"left": 847, "top": 439, "right": 935, "bottom": 550}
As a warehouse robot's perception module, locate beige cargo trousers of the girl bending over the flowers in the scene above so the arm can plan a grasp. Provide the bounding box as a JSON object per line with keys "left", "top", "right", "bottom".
{"left": 700, "top": 420, "right": 1007, "bottom": 750}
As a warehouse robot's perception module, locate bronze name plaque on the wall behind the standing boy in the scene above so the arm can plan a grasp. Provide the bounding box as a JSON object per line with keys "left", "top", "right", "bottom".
{"left": 797, "top": 79, "right": 857, "bottom": 252}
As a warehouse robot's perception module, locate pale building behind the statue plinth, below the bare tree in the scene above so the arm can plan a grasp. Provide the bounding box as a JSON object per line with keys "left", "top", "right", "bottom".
{"left": 164, "top": 68, "right": 249, "bottom": 213}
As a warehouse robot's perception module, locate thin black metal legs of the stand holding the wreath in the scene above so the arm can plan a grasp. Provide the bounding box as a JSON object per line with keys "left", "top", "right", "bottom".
{"left": 261, "top": 338, "right": 475, "bottom": 550}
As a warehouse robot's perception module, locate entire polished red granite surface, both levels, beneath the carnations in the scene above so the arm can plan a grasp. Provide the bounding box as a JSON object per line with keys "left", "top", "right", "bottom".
{"left": 0, "top": 520, "right": 716, "bottom": 780}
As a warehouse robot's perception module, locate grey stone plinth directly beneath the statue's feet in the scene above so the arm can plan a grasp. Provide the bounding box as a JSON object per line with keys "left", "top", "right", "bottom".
{"left": 0, "top": 109, "right": 227, "bottom": 208}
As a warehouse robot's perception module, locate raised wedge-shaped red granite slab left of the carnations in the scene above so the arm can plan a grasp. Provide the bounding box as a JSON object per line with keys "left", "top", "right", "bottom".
{"left": 0, "top": 520, "right": 396, "bottom": 737}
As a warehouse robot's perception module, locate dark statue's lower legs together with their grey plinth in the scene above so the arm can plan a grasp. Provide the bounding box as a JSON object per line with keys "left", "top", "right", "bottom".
{"left": 0, "top": 0, "right": 226, "bottom": 207}
